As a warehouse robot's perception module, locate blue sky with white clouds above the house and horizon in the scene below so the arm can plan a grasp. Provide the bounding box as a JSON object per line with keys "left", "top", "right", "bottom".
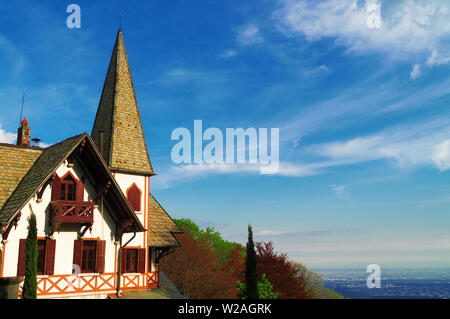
{"left": 0, "top": 0, "right": 450, "bottom": 268}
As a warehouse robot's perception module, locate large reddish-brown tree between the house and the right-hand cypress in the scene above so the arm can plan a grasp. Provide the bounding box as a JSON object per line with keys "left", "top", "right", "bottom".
{"left": 160, "top": 229, "right": 237, "bottom": 299}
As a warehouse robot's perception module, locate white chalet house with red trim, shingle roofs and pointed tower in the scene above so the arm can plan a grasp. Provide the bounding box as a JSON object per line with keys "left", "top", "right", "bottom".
{"left": 0, "top": 30, "right": 180, "bottom": 298}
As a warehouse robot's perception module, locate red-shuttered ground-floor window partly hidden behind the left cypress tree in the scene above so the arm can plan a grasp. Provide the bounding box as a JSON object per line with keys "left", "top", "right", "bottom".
{"left": 17, "top": 239, "right": 56, "bottom": 276}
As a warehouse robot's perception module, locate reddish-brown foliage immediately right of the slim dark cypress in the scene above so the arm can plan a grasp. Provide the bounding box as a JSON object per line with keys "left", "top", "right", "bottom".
{"left": 256, "top": 241, "right": 313, "bottom": 298}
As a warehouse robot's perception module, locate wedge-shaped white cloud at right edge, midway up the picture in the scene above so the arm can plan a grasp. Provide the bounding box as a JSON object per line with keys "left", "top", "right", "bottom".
{"left": 307, "top": 119, "right": 450, "bottom": 170}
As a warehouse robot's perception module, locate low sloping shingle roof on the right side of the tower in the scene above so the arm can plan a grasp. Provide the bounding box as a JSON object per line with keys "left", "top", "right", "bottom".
{"left": 148, "top": 194, "right": 183, "bottom": 247}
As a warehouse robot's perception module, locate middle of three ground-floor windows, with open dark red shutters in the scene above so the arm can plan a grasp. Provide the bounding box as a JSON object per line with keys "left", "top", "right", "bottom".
{"left": 73, "top": 239, "right": 106, "bottom": 273}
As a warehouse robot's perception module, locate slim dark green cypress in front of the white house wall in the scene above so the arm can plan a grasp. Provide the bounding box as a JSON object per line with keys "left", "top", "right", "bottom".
{"left": 22, "top": 212, "right": 38, "bottom": 299}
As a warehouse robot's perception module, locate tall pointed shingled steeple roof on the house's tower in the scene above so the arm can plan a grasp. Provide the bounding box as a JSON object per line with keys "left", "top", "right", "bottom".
{"left": 91, "top": 29, "right": 154, "bottom": 175}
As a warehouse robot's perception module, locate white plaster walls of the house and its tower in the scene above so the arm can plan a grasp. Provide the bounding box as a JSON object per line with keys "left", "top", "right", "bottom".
{"left": 3, "top": 161, "right": 155, "bottom": 277}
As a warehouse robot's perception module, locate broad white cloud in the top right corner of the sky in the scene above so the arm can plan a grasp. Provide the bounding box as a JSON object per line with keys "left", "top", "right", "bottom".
{"left": 275, "top": 0, "right": 450, "bottom": 59}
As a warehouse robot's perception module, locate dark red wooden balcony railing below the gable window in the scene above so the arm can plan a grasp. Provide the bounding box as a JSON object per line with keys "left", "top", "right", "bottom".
{"left": 50, "top": 200, "right": 95, "bottom": 225}
